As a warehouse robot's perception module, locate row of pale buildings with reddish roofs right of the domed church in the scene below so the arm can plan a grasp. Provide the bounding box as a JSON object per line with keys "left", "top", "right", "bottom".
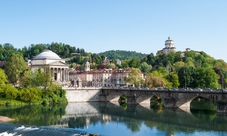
{"left": 69, "top": 62, "right": 131, "bottom": 87}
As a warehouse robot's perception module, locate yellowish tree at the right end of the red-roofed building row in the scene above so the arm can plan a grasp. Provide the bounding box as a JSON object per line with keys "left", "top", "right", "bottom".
{"left": 125, "top": 68, "right": 144, "bottom": 87}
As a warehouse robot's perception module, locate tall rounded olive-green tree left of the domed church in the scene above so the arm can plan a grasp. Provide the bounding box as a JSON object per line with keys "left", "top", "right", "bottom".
{"left": 5, "top": 53, "right": 27, "bottom": 86}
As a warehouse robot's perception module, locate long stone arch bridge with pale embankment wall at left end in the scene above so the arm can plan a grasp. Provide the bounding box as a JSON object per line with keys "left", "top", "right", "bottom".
{"left": 66, "top": 88, "right": 227, "bottom": 109}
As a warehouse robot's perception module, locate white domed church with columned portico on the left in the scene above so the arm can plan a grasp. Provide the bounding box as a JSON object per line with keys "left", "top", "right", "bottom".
{"left": 31, "top": 50, "right": 69, "bottom": 84}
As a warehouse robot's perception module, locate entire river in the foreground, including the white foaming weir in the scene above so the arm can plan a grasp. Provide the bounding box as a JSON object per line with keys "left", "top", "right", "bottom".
{"left": 0, "top": 102, "right": 227, "bottom": 136}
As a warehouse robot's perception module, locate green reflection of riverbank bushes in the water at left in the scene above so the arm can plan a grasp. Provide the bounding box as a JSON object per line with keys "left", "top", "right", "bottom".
{"left": 0, "top": 105, "right": 66, "bottom": 126}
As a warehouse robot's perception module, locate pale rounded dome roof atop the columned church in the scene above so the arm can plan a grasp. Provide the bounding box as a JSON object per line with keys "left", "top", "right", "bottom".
{"left": 34, "top": 50, "right": 61, "bottom": 59}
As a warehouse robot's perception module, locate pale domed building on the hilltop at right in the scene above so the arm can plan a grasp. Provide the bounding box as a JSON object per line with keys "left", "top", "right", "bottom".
{"left": 157, "top": 37, "right": 176, "bottom": 55}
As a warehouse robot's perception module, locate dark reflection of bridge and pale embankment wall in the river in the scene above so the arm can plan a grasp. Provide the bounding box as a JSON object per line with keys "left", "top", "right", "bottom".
{"left": 61, "top": 102, "right": 227, "bottom": 132}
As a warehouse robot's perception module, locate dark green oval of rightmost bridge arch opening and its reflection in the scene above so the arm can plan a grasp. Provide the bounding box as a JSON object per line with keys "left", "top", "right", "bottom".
{"left": 190, "top": 97, "right": 217, "bottom": 121}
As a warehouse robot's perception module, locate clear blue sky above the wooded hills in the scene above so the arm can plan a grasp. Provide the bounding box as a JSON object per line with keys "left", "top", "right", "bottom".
{"left": 0, "top": 0, "right": 227, "bottom": 62}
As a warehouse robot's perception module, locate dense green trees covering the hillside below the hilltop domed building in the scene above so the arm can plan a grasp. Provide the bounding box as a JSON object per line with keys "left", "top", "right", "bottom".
{"left": 141, "top": 51, "right": 227, "bottom": 88}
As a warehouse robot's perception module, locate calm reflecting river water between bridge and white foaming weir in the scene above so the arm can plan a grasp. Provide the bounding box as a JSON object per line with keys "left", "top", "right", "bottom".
{"left": 0, "top": 102, "right": 227, "bottom": 135}
